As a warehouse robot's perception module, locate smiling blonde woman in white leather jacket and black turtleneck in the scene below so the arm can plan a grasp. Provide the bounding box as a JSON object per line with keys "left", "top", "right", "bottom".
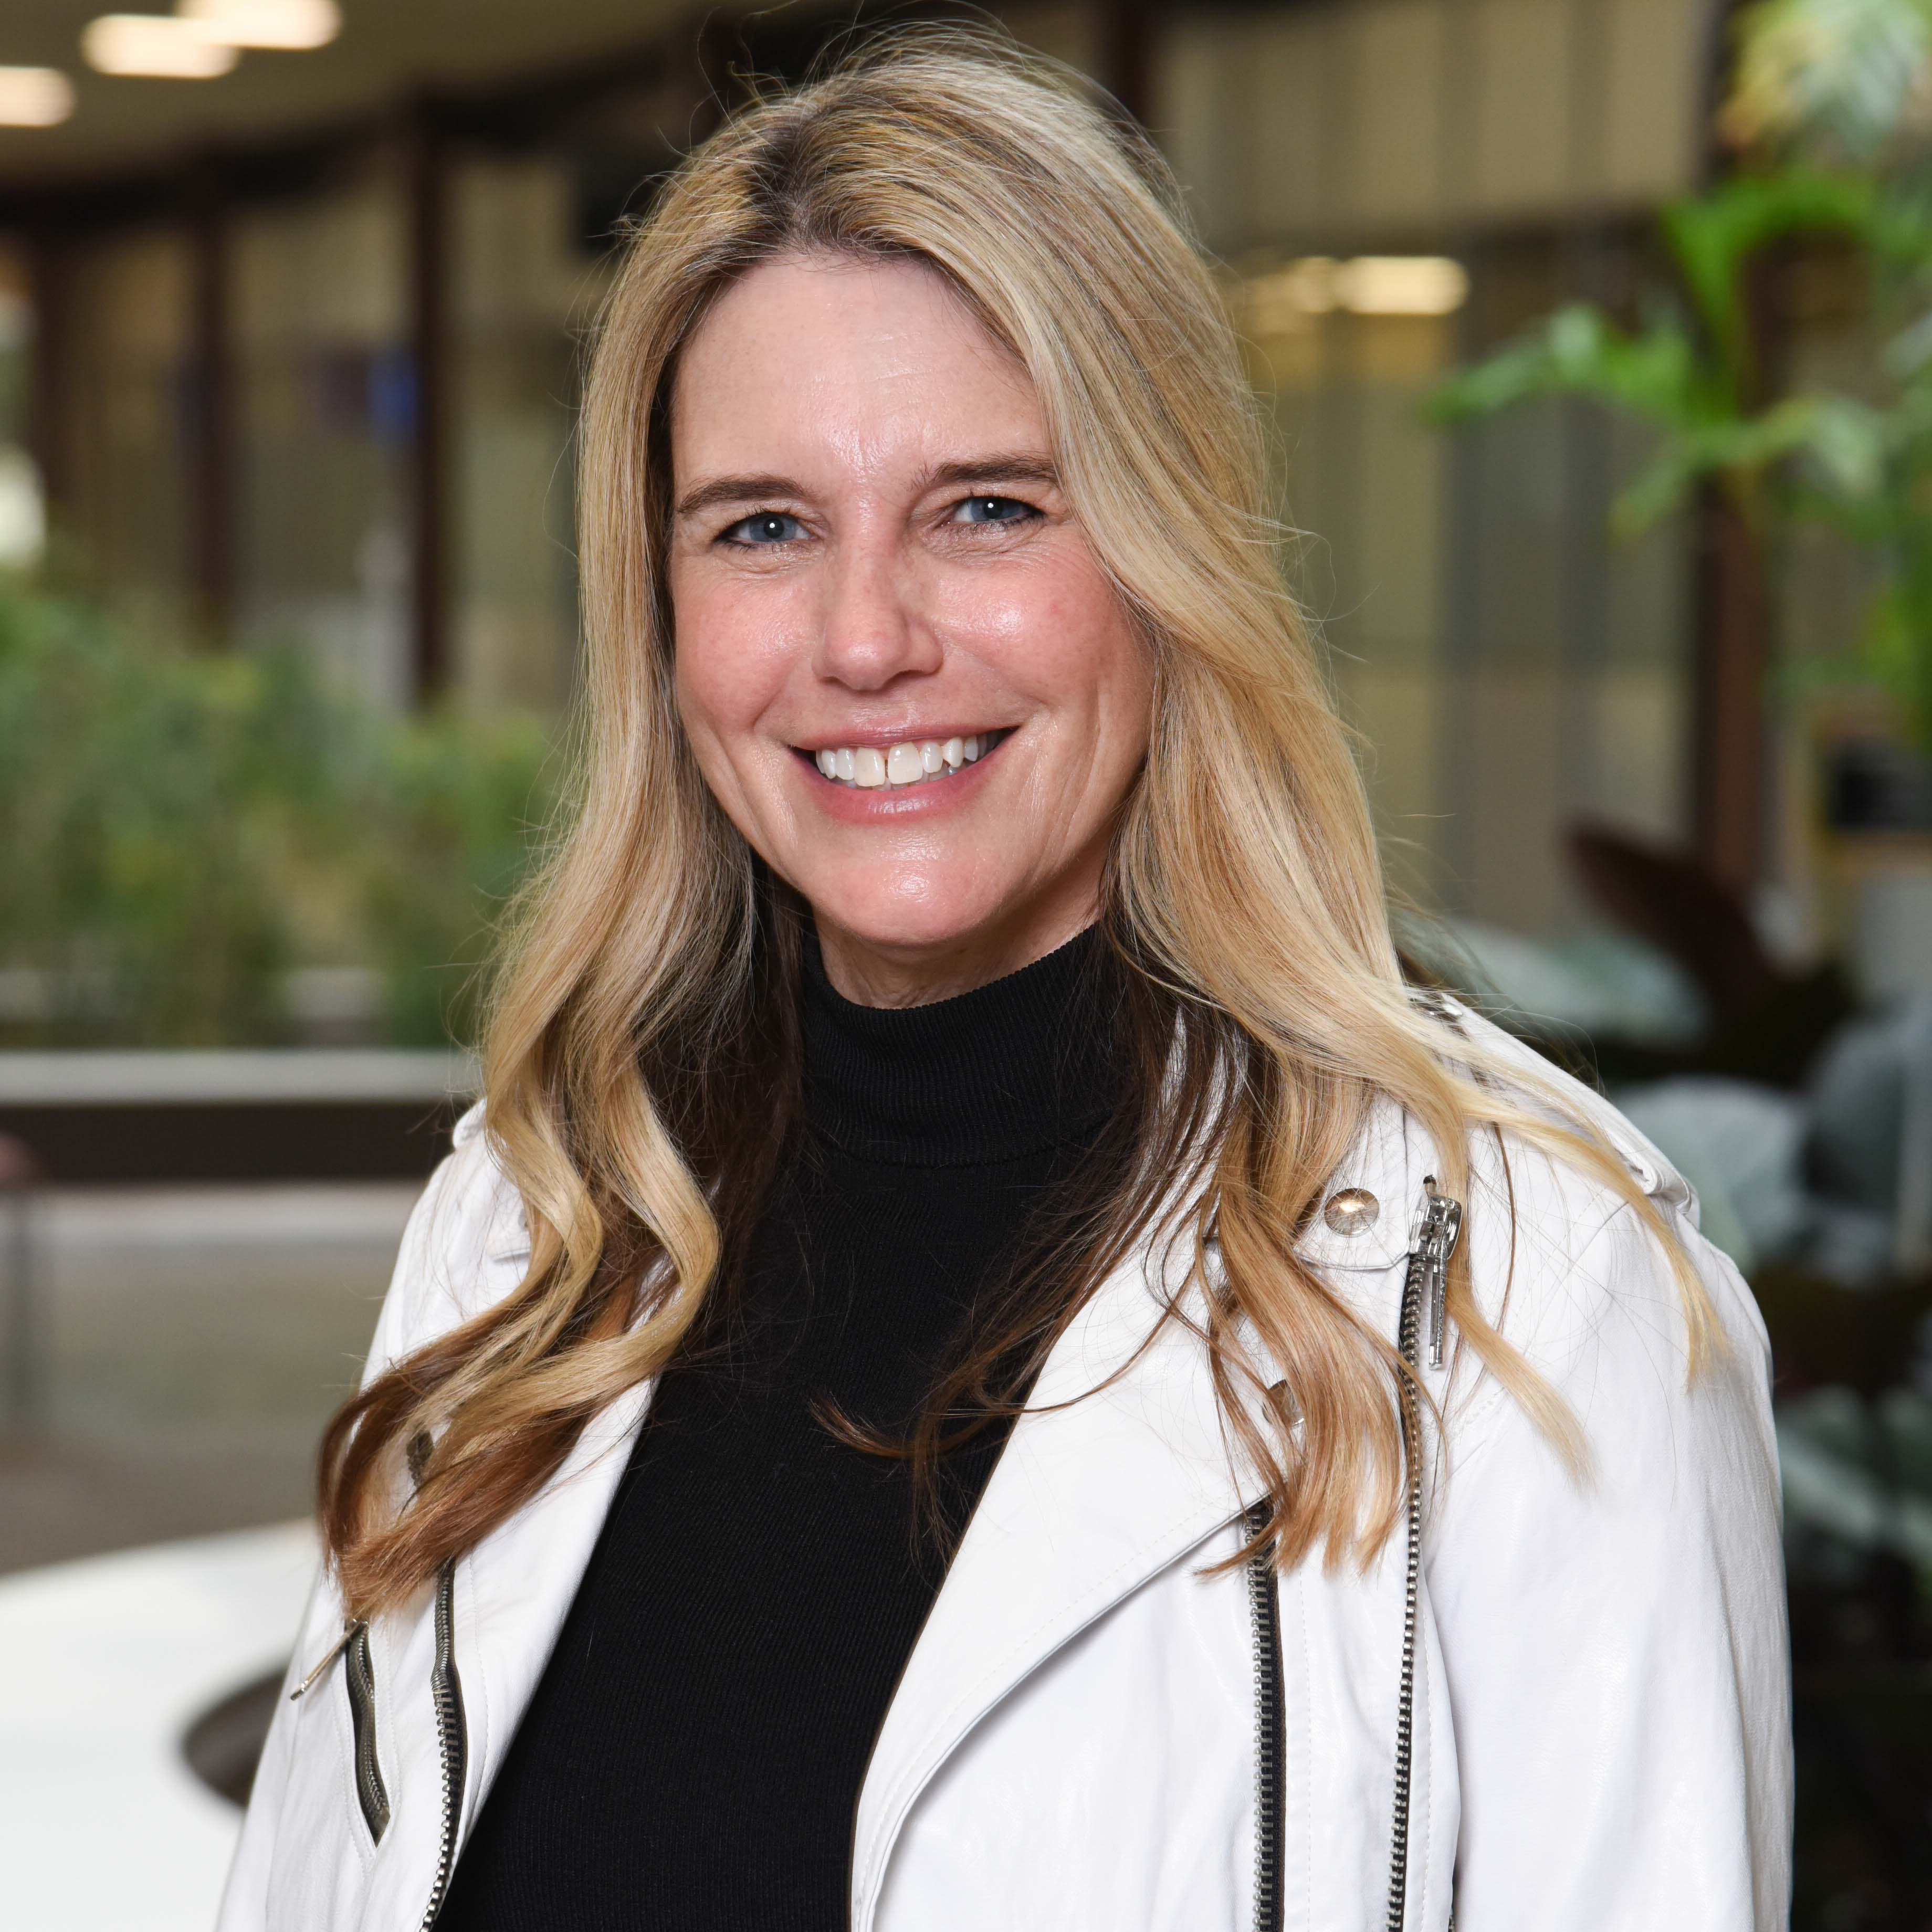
{"left": 222, "top": 39, "right": 1789, "bottom": 1932}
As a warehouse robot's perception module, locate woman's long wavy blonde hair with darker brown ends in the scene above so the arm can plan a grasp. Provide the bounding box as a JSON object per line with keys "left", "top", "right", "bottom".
{"left": 323, "top": 33, "right": 1712, "bottom": 1613}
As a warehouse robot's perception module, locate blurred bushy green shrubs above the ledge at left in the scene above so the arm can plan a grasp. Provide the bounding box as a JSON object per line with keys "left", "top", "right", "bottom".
{"left": 0, "top": 580, "right": 551, "bottom": 1045}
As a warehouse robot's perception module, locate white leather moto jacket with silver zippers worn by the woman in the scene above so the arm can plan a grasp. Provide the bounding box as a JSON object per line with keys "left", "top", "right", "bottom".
{"left": 220, "top": 1020, "right": 1791, "bottom": 1932}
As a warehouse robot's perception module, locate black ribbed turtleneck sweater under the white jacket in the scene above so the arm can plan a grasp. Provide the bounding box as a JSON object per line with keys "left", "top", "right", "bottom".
{"left": 438, "top": 933, "right": 1122, "bottom": 1932}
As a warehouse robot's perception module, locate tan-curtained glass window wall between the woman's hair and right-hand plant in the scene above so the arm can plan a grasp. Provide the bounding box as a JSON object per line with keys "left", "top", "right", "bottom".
{"left": 1156, "top": 0, "right": 1696, "bottom": 933}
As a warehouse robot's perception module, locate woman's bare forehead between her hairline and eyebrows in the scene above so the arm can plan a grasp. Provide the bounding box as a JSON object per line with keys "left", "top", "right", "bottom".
{"left": 670, "top": 255, "right": 1045, "bottom": 487}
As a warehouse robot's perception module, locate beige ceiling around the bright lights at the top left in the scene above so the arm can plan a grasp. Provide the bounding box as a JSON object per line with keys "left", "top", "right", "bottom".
{"left": 0, "top": 0, "right": 699, "bottom": 187}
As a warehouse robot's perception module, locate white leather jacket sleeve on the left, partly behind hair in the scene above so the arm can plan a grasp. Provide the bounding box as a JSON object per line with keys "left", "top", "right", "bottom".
{"left": 216, "top": 1153, "right": 469, "bottom": 1932}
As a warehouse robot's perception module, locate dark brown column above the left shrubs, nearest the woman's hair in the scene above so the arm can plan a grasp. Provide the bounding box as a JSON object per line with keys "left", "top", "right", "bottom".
{"left": 407, "top": 110, "right": 450, "bottom": 704}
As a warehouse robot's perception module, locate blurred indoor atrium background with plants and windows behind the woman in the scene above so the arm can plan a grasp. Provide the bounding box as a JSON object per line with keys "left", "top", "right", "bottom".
{"left": 0, "top": 0, "right": 1932, "bottom": 1932}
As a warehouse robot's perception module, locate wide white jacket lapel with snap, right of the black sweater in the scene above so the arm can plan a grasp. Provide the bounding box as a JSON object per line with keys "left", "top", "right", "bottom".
{"left": 852, "top": 1105, "right": 1422, "bottom": 1932}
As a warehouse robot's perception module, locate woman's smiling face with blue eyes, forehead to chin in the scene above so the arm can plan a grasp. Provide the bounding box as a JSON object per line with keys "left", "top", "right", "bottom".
{"left": 670, "top": 255, "right": 1151, "bottom": 1005}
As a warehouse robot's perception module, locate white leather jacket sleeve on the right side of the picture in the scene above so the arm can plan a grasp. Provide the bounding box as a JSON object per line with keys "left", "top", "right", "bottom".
{"left": 1426, "top": 1208, "right": 1791, "bottom": 1932}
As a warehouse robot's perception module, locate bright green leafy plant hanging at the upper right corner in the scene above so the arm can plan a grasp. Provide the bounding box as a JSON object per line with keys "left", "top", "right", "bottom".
{"left": 1430, "top": 0, "right": 1932, "bottom": 750}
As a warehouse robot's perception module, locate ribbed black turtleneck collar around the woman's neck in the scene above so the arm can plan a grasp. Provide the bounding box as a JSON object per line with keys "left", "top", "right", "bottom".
{"left": 806, "top": 927, "right": 1126, "bottom": 1167}
